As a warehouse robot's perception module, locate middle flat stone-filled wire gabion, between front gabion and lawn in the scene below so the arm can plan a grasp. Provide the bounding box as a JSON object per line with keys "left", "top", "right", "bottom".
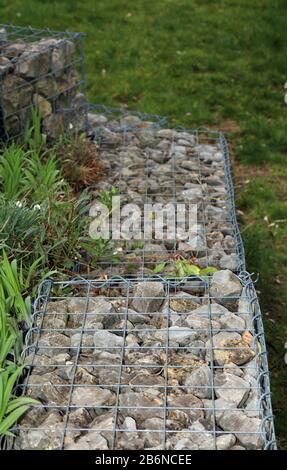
{"left": 85, "top": 127, "right": 245, "bottom": 275}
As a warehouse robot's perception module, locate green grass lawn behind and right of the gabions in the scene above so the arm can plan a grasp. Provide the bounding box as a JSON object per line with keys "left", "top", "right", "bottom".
{"left": 1, "top": 0, "right": 287, "bottom": 448}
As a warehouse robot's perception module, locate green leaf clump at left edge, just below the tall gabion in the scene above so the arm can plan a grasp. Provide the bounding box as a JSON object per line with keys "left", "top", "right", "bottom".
{"left": 0, "top": 143, "right": 26, "bottom": 200}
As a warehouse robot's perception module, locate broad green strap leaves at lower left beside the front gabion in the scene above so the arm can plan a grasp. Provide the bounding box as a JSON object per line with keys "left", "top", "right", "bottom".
{"left": 0, "top": 364, "right": 38, "bottom": 436}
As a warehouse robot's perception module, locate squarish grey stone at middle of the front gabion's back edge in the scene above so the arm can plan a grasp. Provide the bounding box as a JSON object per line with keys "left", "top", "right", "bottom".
{"left": 132, "top": 281, "right": 164, "bottom": 313}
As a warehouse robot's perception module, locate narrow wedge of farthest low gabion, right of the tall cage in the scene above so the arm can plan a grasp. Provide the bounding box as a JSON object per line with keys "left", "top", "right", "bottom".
{"left": 88, "top": 103, "right": 167, "bottom": 133}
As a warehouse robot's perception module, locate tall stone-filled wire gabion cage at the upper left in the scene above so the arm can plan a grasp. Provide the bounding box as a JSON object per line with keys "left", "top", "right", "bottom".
{"left": 0, "top": 25, "right": 87, "bottom": 140}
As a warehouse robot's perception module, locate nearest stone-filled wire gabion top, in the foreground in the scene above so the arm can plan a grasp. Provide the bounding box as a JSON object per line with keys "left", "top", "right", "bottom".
{"left": 6, "top": 272, "right": 276, "bottom": 450}
